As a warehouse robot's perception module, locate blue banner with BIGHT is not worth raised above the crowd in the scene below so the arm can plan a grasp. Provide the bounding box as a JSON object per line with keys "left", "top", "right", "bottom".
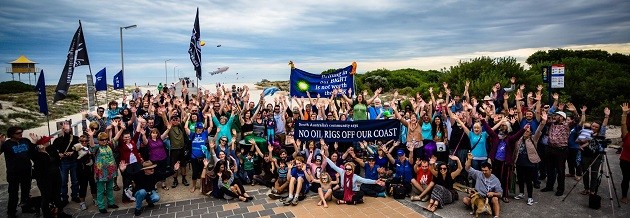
{"left": 289, "top": 65, "right": 354, "bottom": 98}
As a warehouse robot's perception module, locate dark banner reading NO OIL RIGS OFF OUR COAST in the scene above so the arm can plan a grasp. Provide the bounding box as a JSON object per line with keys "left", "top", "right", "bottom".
{"left": 293, "top": 120, "right": 400, "bottom": 142}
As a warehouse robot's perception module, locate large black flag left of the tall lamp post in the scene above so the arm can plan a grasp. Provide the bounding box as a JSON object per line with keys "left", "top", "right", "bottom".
{"left": 53, "top": 21, "right": 90, "bottom": 103}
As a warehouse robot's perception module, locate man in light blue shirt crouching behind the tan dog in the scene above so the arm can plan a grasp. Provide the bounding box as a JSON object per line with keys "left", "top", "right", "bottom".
{"left": 463, "top": 153, "right": 503, "bottom": 217}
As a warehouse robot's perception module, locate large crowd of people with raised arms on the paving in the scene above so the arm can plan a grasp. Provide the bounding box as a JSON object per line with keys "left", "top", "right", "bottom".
{"left": 0, "top": 78, "right": 630, "bottom": 217}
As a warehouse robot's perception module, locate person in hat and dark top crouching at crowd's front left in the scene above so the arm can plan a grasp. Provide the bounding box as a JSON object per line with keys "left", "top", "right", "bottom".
{"left": 120, "top": 161, "right": 179, "bottom": 216}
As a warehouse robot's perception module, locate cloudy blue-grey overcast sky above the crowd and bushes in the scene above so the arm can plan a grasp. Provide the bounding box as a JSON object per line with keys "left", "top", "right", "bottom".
{"left": 0, "top": 0, "right": 630, "bottom": 85}
